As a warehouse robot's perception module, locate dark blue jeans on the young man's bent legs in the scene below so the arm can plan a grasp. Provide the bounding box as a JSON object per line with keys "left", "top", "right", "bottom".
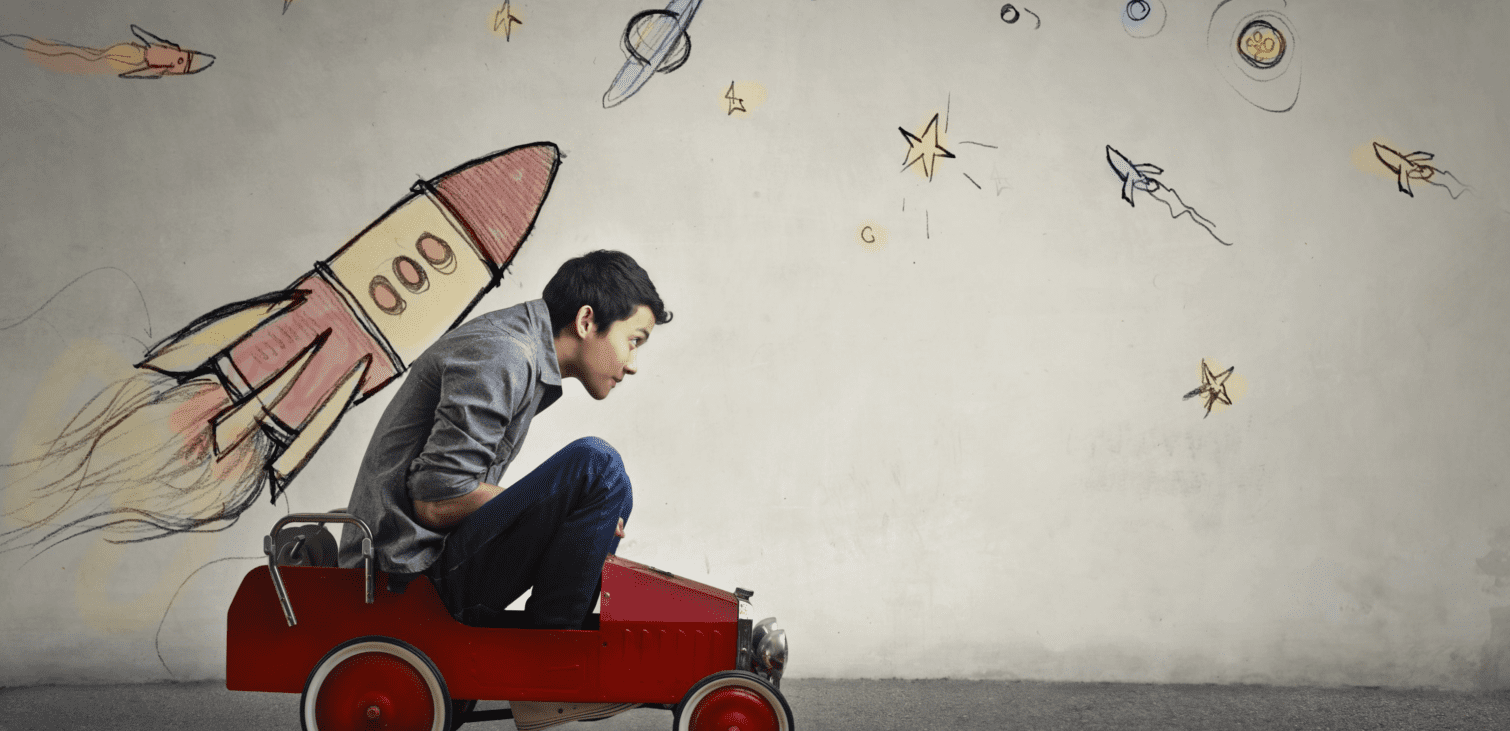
{"left": 426, "top": 436, "right": 634, "bottom": 630}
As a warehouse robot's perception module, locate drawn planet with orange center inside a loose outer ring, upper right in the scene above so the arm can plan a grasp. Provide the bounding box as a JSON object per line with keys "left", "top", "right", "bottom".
{"left": 1206, "top": 0, "right": 1300, "bottom": 112}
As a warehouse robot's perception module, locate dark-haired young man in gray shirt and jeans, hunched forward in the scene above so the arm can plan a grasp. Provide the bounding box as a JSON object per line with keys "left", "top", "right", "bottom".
{"left": 341, "top": 251, "right": 670, "bottom": 630}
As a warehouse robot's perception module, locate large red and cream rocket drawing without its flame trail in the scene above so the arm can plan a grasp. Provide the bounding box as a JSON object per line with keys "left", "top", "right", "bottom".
{"left": 137, "top": 142, "right": 560, "bottom": 498}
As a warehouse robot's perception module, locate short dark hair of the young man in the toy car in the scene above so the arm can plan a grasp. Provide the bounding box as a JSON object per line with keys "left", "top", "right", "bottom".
{"left": 541, "top": 249, "right": 670, "bottom": 334}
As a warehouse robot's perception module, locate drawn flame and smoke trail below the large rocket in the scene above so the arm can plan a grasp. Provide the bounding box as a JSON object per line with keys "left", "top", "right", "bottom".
{"left": 0, "top": 372, "right": 273, "bottom": 554}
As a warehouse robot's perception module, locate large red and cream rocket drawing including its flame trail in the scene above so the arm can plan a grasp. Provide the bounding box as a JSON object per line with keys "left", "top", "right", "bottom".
{"left": 0, "top": 142, "right": 560, "bottom": 553}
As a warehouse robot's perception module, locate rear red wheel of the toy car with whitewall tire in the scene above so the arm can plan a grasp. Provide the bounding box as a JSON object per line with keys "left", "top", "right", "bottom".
{"left": 299, "top": 636, "right": 451, "bottom": 731}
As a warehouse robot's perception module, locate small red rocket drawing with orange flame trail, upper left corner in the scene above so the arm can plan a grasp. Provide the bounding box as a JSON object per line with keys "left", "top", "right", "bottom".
{"left": 0, "top": 26, "right": 214, "bottom": 79}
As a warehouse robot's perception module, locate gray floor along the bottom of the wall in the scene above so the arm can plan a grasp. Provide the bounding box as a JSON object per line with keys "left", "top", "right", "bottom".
{"left": 0, "top": 678, "right": 1510, "bottom": 731}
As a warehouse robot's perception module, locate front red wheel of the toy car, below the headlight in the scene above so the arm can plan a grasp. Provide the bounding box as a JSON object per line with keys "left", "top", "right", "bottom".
{"left": 672, "top": 671, "right": 796, "bottom": 731}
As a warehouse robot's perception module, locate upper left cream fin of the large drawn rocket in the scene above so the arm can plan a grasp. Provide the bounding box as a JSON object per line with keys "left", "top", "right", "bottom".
{"left": 136, "top": 290, "right": 305, "bottom": 376}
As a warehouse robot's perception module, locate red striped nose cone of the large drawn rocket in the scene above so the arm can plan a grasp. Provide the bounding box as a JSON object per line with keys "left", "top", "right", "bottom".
{"left": 430, "top": 142, "right": 562, "bottom": 269}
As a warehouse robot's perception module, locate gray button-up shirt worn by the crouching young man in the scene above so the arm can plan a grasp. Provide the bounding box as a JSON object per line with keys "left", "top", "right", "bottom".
{"left": 341, "top": 299, "right": 562, "bottom": 572}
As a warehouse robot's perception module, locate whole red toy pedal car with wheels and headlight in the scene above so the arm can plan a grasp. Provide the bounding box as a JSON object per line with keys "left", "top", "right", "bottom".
{"left": 225, "top": 512, "right": 794, "bottom": 731}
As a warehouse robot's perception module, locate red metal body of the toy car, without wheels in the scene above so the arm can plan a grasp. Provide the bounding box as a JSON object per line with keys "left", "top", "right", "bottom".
{"left": 225, "top": 556, "right": 738, "bottom": 704}
